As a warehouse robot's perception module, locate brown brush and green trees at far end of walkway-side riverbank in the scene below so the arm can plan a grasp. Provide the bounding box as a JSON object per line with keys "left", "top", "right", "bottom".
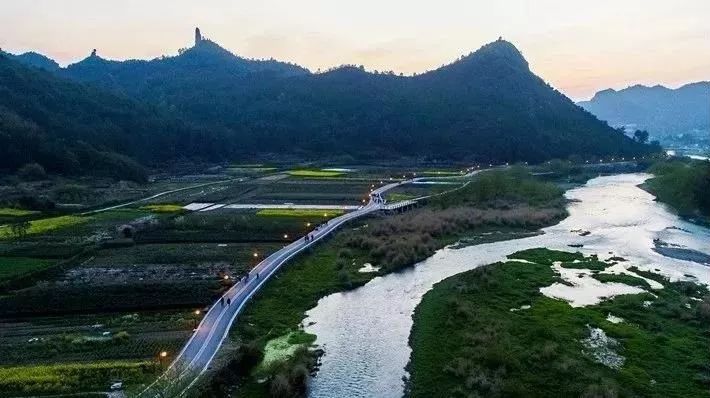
{"left": 346, "top": 168, "right": 567, "bottom": 273}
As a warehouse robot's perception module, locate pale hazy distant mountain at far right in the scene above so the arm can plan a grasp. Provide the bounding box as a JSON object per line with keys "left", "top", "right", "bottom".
{"left": 579, "top": 82, "right": 710, "bottom": 138}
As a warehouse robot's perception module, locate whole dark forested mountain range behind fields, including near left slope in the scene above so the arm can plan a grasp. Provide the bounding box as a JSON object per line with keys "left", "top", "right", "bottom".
{"left": 0, "top": 33, "right": 658, "bottom": 179}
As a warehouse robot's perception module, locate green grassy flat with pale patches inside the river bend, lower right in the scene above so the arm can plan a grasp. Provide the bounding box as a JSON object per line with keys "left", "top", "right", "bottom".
{"left": 408, "top": 250, "right": 710, "bottom": 398}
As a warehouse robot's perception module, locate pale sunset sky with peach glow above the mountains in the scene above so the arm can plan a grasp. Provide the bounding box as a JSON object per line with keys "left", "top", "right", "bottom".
{"left": 0, "top": 0, "right": 710, "bottom": 100}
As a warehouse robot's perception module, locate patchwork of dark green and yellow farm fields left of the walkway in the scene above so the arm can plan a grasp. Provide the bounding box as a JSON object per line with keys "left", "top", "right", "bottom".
{"left": 0, "top": 164, "right": 478, "bottom": 396}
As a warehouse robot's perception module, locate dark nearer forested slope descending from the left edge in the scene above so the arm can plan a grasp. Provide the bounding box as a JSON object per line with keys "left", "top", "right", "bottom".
{"left": 0, "top": 54, "right": 225, "bottom": 181}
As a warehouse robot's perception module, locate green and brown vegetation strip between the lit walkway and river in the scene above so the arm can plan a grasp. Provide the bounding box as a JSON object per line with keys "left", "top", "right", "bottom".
{"left": 199, "top": 169, "right": 566, "bottom": 397}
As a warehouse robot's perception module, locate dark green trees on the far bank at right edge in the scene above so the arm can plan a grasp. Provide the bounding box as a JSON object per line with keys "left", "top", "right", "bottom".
{"left": 644, "top": 160, "right": 710, "bottom": 222}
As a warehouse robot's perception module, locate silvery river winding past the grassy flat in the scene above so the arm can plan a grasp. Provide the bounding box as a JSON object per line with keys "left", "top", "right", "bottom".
{"left": 304, "top": 174, "right": 710, "bottom": 398}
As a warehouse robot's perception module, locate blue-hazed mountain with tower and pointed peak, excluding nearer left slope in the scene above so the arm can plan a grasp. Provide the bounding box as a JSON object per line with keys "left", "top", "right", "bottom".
{"left": 58, "top": 34, "right": 660, "bottom": 161}
